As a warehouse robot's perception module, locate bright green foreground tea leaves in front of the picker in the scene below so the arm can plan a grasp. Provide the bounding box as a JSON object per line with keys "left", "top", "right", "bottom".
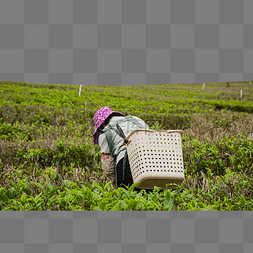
{"left": 0, "top": 178, "right": 253, "bottom": 211}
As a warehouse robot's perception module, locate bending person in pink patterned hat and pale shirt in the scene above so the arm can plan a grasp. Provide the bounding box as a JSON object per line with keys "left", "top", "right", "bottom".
{"left": 93, "top": 106, "right": 149, "bottom": 189}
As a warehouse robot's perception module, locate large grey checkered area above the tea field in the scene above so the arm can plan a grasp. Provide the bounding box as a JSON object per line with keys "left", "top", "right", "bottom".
{"left": 0, "top": 0, "right": 253, "bottom": 86}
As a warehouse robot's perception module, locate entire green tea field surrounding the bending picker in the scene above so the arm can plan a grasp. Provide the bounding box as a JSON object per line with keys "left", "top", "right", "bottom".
{"left": 0, "top": 81, "right": 253, "bottom": 210}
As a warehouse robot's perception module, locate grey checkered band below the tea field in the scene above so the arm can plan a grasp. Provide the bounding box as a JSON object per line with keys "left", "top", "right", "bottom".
{"left": 0, "top": 211, "right": 253, "bottom": 253}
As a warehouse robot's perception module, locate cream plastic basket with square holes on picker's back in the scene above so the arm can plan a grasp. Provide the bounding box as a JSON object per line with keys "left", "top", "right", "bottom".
{"left": 126, "top": 130, "right": 185, "bottom": 189}
